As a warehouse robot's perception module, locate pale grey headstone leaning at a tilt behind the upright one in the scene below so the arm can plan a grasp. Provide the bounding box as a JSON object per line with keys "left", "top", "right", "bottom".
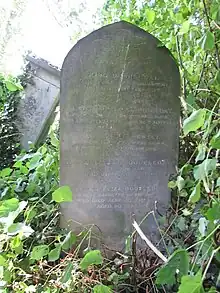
{"left": 17, "top": 56, "right": 60, "bottom": 150}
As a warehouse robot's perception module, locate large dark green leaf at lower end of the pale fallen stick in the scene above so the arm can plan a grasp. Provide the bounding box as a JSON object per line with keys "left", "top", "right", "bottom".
{"left": 156, "top": 249, "right": 189, "bottom": 286}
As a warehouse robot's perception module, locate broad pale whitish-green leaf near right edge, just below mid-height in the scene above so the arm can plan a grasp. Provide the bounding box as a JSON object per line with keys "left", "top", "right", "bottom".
{"left": 193, "top": 159, "right": 217, "bottom": 180}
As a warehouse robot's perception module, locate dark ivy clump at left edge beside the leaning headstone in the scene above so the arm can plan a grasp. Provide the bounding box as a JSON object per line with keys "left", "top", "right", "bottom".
{"left": 0, "top": 75, "right": 23, "bottom": 170}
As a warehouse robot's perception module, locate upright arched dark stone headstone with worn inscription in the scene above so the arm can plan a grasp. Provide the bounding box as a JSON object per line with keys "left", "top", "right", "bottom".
{"left": 60, "top": 22, "right": 180, "bottom": 250}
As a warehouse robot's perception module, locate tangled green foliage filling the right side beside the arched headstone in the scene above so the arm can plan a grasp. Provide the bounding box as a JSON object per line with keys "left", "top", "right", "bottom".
{"left": 103, "top": 0, "right": 220, "bottom": 293}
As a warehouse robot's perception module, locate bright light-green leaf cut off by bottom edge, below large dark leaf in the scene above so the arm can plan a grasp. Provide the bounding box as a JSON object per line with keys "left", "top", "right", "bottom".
{"left": 178, "top": 271, "right": 205, "bottom": 293}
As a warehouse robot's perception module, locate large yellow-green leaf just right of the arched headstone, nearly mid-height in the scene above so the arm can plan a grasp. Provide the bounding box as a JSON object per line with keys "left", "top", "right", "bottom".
{"left": 183, "top": 109, "right": 206, "bottom": 135}
